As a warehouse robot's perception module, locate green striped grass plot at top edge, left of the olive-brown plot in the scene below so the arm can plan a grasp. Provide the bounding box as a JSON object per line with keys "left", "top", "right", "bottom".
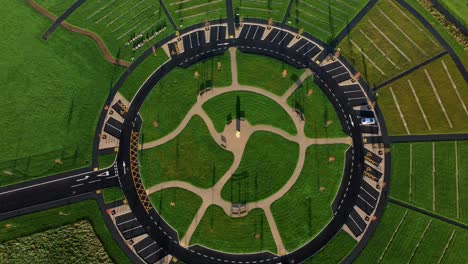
{"left": 287, "top": 0, "right": 369, "bottom": 43}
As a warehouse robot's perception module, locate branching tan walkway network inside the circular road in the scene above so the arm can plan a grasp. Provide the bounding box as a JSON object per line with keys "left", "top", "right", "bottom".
{"left": 143, "top": 48, "right": 352, "bottom": 255}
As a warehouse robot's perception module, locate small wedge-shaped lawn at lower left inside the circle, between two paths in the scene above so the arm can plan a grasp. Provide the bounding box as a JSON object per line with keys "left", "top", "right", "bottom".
{"left": 150, "top": 188, "right": 202, "bottom": 240}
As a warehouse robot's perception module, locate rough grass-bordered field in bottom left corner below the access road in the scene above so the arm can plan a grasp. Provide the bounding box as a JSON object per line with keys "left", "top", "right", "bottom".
{"left": 0, "top": 200, "right": 131, "bottom": 264}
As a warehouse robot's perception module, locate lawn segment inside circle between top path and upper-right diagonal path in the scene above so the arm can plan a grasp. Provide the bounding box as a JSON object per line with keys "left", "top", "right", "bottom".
{"left": 237, "top": 51, "right": 304, "bottom": 95}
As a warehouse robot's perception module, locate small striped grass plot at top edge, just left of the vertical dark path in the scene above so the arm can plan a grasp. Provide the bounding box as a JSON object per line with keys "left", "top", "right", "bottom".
{"left": 163, "top": 0, "right": 227, "bottom": 28}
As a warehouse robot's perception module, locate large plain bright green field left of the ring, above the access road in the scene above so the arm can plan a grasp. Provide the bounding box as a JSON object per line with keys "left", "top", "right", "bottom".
{"left": 0, "top": 1, "right": 122, "bottom": 188}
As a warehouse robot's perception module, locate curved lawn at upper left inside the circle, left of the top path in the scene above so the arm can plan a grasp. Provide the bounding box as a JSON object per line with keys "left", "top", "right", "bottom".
{"left": 140, "top": 53, "right": 232, "bottom": 142}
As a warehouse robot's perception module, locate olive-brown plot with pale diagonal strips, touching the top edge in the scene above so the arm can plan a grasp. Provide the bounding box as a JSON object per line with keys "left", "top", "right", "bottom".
{"left": 339, "top": 0, "right": 443, "bottom": 87}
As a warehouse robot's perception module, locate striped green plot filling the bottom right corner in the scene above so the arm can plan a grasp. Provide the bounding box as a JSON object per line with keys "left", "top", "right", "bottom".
{"left": 355, "top": 204, "right": 468, "bottom": 263}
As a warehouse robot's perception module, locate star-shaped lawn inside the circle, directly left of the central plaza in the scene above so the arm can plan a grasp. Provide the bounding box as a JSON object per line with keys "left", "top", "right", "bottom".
{"left": 140, "top": 116, "right": 233, "bottom": 188}
